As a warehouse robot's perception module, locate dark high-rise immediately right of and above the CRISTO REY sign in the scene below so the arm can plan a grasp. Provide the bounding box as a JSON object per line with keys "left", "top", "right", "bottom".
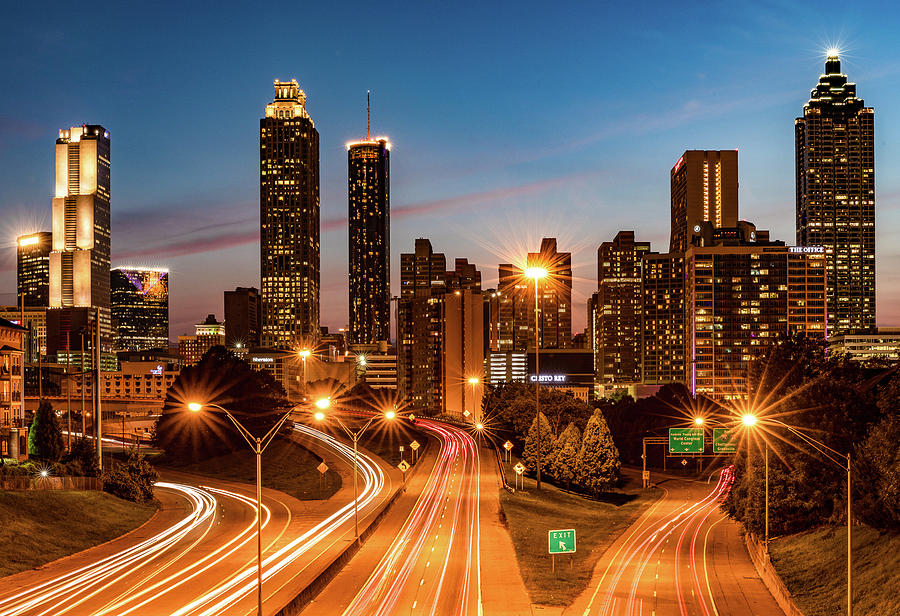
{"left": 594, "top": 231, "right": 650, "bottom": 389}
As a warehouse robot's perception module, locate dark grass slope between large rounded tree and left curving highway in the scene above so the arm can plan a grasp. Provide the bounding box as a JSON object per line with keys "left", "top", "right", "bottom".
{"left": 161, "top": 439, "right": 341, "bottom": 500}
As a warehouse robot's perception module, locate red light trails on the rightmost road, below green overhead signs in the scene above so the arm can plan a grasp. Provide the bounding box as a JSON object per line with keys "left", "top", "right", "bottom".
{"left": 584, "top": 466, "right": 734, "bottom": 616}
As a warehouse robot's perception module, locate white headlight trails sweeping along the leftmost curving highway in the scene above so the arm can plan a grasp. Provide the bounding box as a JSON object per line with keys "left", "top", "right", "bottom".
{"left": 0, "top": 424, "right": 386, "bottom": 616}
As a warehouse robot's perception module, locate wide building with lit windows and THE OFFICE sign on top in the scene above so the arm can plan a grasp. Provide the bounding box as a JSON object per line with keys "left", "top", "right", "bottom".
{"left": 684, "top": 236, "right": 826, "bottom": 400}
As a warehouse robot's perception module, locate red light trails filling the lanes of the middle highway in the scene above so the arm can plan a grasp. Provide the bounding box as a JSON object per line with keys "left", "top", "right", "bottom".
{"left": 344, "top": 420, "right": 481, "bottom": 616}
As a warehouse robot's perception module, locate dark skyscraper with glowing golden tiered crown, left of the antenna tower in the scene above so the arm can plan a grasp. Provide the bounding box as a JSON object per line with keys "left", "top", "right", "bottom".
{"left": 259, "top": 79, "right": 319, "bottom": 348}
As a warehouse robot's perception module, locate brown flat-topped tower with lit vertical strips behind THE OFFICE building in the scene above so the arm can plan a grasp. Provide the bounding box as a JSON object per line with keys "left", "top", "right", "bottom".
{"left": 669, "top": 150, "right": 738, "bottom": 252}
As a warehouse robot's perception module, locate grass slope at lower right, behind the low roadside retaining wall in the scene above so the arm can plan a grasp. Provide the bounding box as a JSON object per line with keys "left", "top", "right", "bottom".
{"left": 769, "top": 526, "right": 900, "bottom": 616}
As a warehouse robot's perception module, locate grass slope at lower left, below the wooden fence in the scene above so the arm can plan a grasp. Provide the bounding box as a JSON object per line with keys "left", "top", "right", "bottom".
{"left": 0, "top": 490, "right": 156, "bottom": 576}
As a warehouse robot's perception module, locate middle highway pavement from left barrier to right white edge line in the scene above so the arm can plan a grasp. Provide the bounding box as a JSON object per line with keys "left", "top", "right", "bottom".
{"left": 303, "top": 420, "right": 486, "bottom": 616}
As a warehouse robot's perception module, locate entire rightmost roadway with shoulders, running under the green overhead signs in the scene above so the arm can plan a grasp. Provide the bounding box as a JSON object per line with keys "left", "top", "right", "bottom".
{"left": 564, "top": 468, "right": 783, "bottom": 616}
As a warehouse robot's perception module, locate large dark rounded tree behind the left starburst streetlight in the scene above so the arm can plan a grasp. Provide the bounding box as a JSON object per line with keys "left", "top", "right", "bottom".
{"left": 154, "top": 347, "right": 289, "bottom": 462}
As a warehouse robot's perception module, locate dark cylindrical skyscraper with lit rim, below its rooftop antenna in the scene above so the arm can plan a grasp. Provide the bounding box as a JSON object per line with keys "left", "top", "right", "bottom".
{"left": 347, "top": 132, "right": 391, "bottom": 344}
